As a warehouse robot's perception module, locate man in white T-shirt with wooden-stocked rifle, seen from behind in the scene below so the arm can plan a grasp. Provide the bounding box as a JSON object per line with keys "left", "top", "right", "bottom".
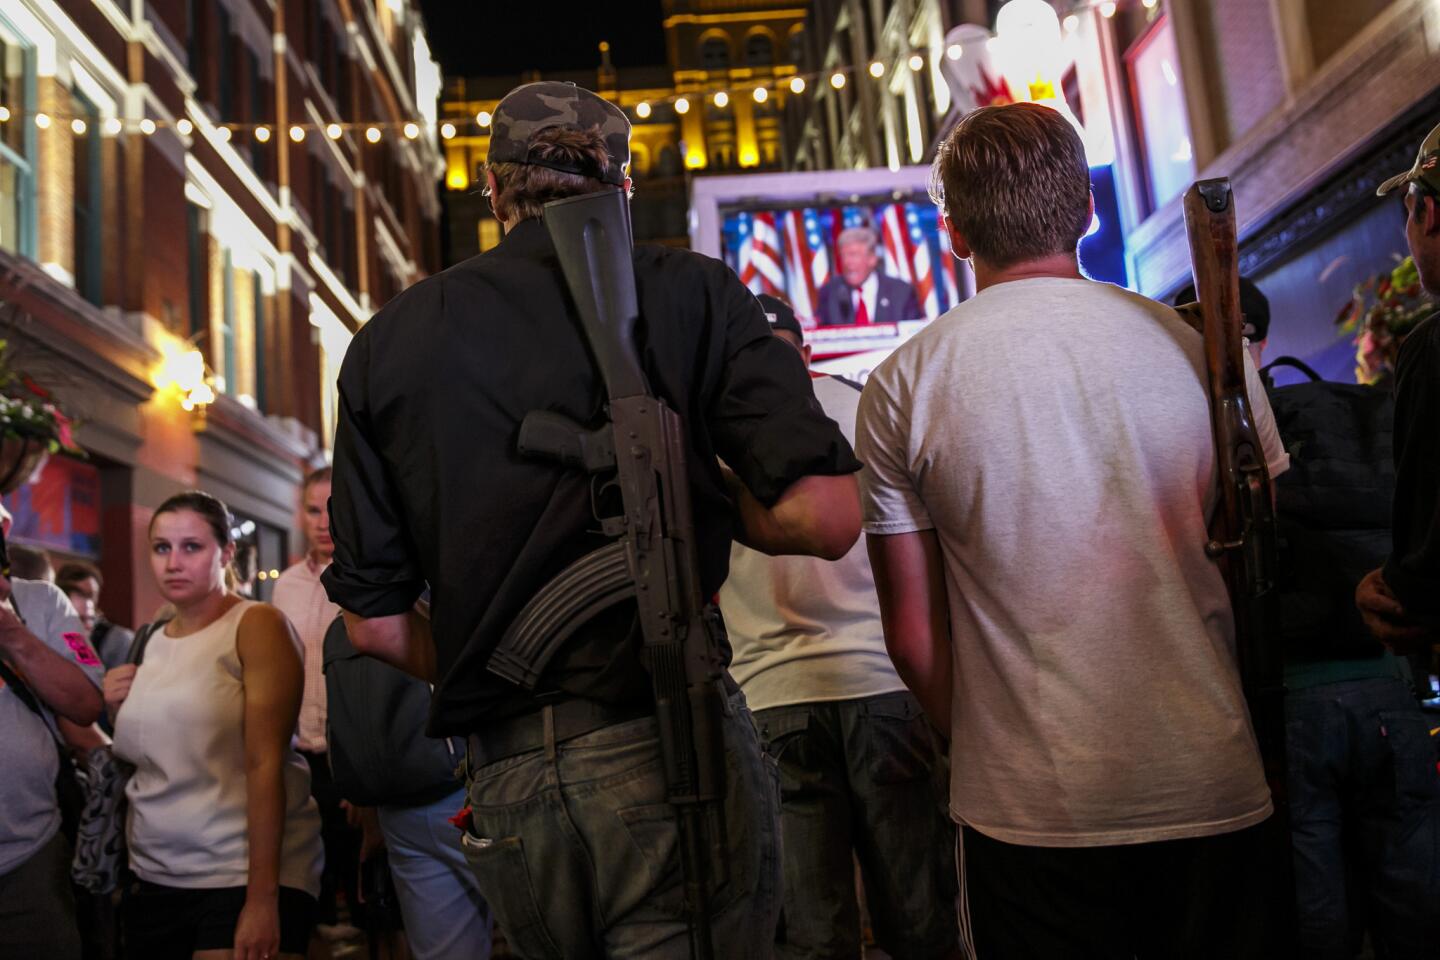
{"left": 857, "top": 104, "right": 1289, "bottom": 960}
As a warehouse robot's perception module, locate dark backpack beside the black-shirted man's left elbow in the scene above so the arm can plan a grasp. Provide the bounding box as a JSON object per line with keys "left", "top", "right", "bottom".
{"left": 325, "top": 617, "right": 462, "bottom": 806}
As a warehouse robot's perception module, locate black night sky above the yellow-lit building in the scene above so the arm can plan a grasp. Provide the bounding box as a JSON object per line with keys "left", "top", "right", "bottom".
{"left": 420, "top": 0, "right": 665, "bottom": 76}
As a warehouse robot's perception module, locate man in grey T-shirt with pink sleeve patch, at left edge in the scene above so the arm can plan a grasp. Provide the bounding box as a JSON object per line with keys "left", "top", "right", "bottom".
{"left": 0, "top": 495, "right": 104, "bottom": 960}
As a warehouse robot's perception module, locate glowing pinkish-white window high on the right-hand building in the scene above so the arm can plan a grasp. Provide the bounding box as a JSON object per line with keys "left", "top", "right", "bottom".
{"left": 1125, "top": 16, "right": 1195, "bottom": 212}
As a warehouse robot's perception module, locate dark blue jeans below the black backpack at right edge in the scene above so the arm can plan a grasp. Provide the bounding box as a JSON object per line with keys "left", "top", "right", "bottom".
{"left": 1286, "top": 679, "right": 1440, "bottom": 960}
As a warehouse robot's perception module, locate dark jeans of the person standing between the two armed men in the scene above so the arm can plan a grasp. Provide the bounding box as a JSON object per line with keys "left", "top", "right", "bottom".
{"left": 755, "top": 692, "right": 959, "bottom": 960}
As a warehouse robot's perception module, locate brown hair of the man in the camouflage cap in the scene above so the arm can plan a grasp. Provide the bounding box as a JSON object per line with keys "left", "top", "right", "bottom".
{"left": 487, "top": 127, "right": 619, "bottom": 220}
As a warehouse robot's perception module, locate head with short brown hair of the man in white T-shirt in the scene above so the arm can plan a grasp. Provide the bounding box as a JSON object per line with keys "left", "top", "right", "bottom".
{"left": 930, "top": 104, "right": 1090, "bottom": 268}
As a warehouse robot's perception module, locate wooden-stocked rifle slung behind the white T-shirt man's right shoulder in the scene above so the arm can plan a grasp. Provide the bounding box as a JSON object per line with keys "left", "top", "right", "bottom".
{"left": 1185, "top": 178, "right": 1293, "bottom": 932}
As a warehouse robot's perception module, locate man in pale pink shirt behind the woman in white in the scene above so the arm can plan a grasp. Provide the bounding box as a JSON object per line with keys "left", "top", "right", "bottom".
{"left": 271, "top": 466, "right": 361, "bottom": 940}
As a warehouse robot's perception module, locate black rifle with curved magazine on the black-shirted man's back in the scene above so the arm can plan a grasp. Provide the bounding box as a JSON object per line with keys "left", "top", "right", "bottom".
{"left": 488, "top": 190, "right": 726, "bottom": 960}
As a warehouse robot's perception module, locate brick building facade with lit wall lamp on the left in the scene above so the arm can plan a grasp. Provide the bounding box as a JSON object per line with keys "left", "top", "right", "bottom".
{"left": 0, "top": 0, "right": 442, "bottom": 623}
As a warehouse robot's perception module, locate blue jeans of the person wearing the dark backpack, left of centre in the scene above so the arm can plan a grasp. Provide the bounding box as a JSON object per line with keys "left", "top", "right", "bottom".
{"left": 376, "top": 787, "right": 491, "bottom": 960}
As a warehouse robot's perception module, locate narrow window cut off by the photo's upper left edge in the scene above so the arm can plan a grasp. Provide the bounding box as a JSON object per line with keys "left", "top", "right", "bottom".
{"left": 0, "top": 16, "right": 36, "bottom": 259}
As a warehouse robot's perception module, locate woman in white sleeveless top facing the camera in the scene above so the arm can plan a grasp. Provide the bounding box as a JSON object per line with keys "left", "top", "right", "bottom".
{"left": 105, "top": 492, "right": 324, "bottom": 960}
